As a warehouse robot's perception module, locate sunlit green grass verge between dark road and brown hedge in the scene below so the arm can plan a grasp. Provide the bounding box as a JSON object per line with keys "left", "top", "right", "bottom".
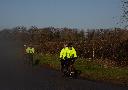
{"left": 36, "top": 54, "right": 128, "bottom": 84}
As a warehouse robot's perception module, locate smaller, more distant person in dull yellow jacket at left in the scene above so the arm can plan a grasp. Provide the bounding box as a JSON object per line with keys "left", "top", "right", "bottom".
{"left": 26, "top": 45, "right": 35, "bottom": 65}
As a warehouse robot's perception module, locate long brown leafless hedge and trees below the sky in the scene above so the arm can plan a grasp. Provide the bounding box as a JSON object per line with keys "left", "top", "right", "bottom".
{"left": 0, "top": 26, "right": 128, "bottom": 65}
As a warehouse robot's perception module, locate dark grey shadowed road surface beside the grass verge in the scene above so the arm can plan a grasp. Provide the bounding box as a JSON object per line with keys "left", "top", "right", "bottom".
{"left": 0, "top": 39, "right": 128, "bottom": 90}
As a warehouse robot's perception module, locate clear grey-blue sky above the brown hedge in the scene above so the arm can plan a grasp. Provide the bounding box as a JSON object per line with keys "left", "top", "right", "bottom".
{"left": 0, "top": 0, "right": 121, "bottom": 28}
